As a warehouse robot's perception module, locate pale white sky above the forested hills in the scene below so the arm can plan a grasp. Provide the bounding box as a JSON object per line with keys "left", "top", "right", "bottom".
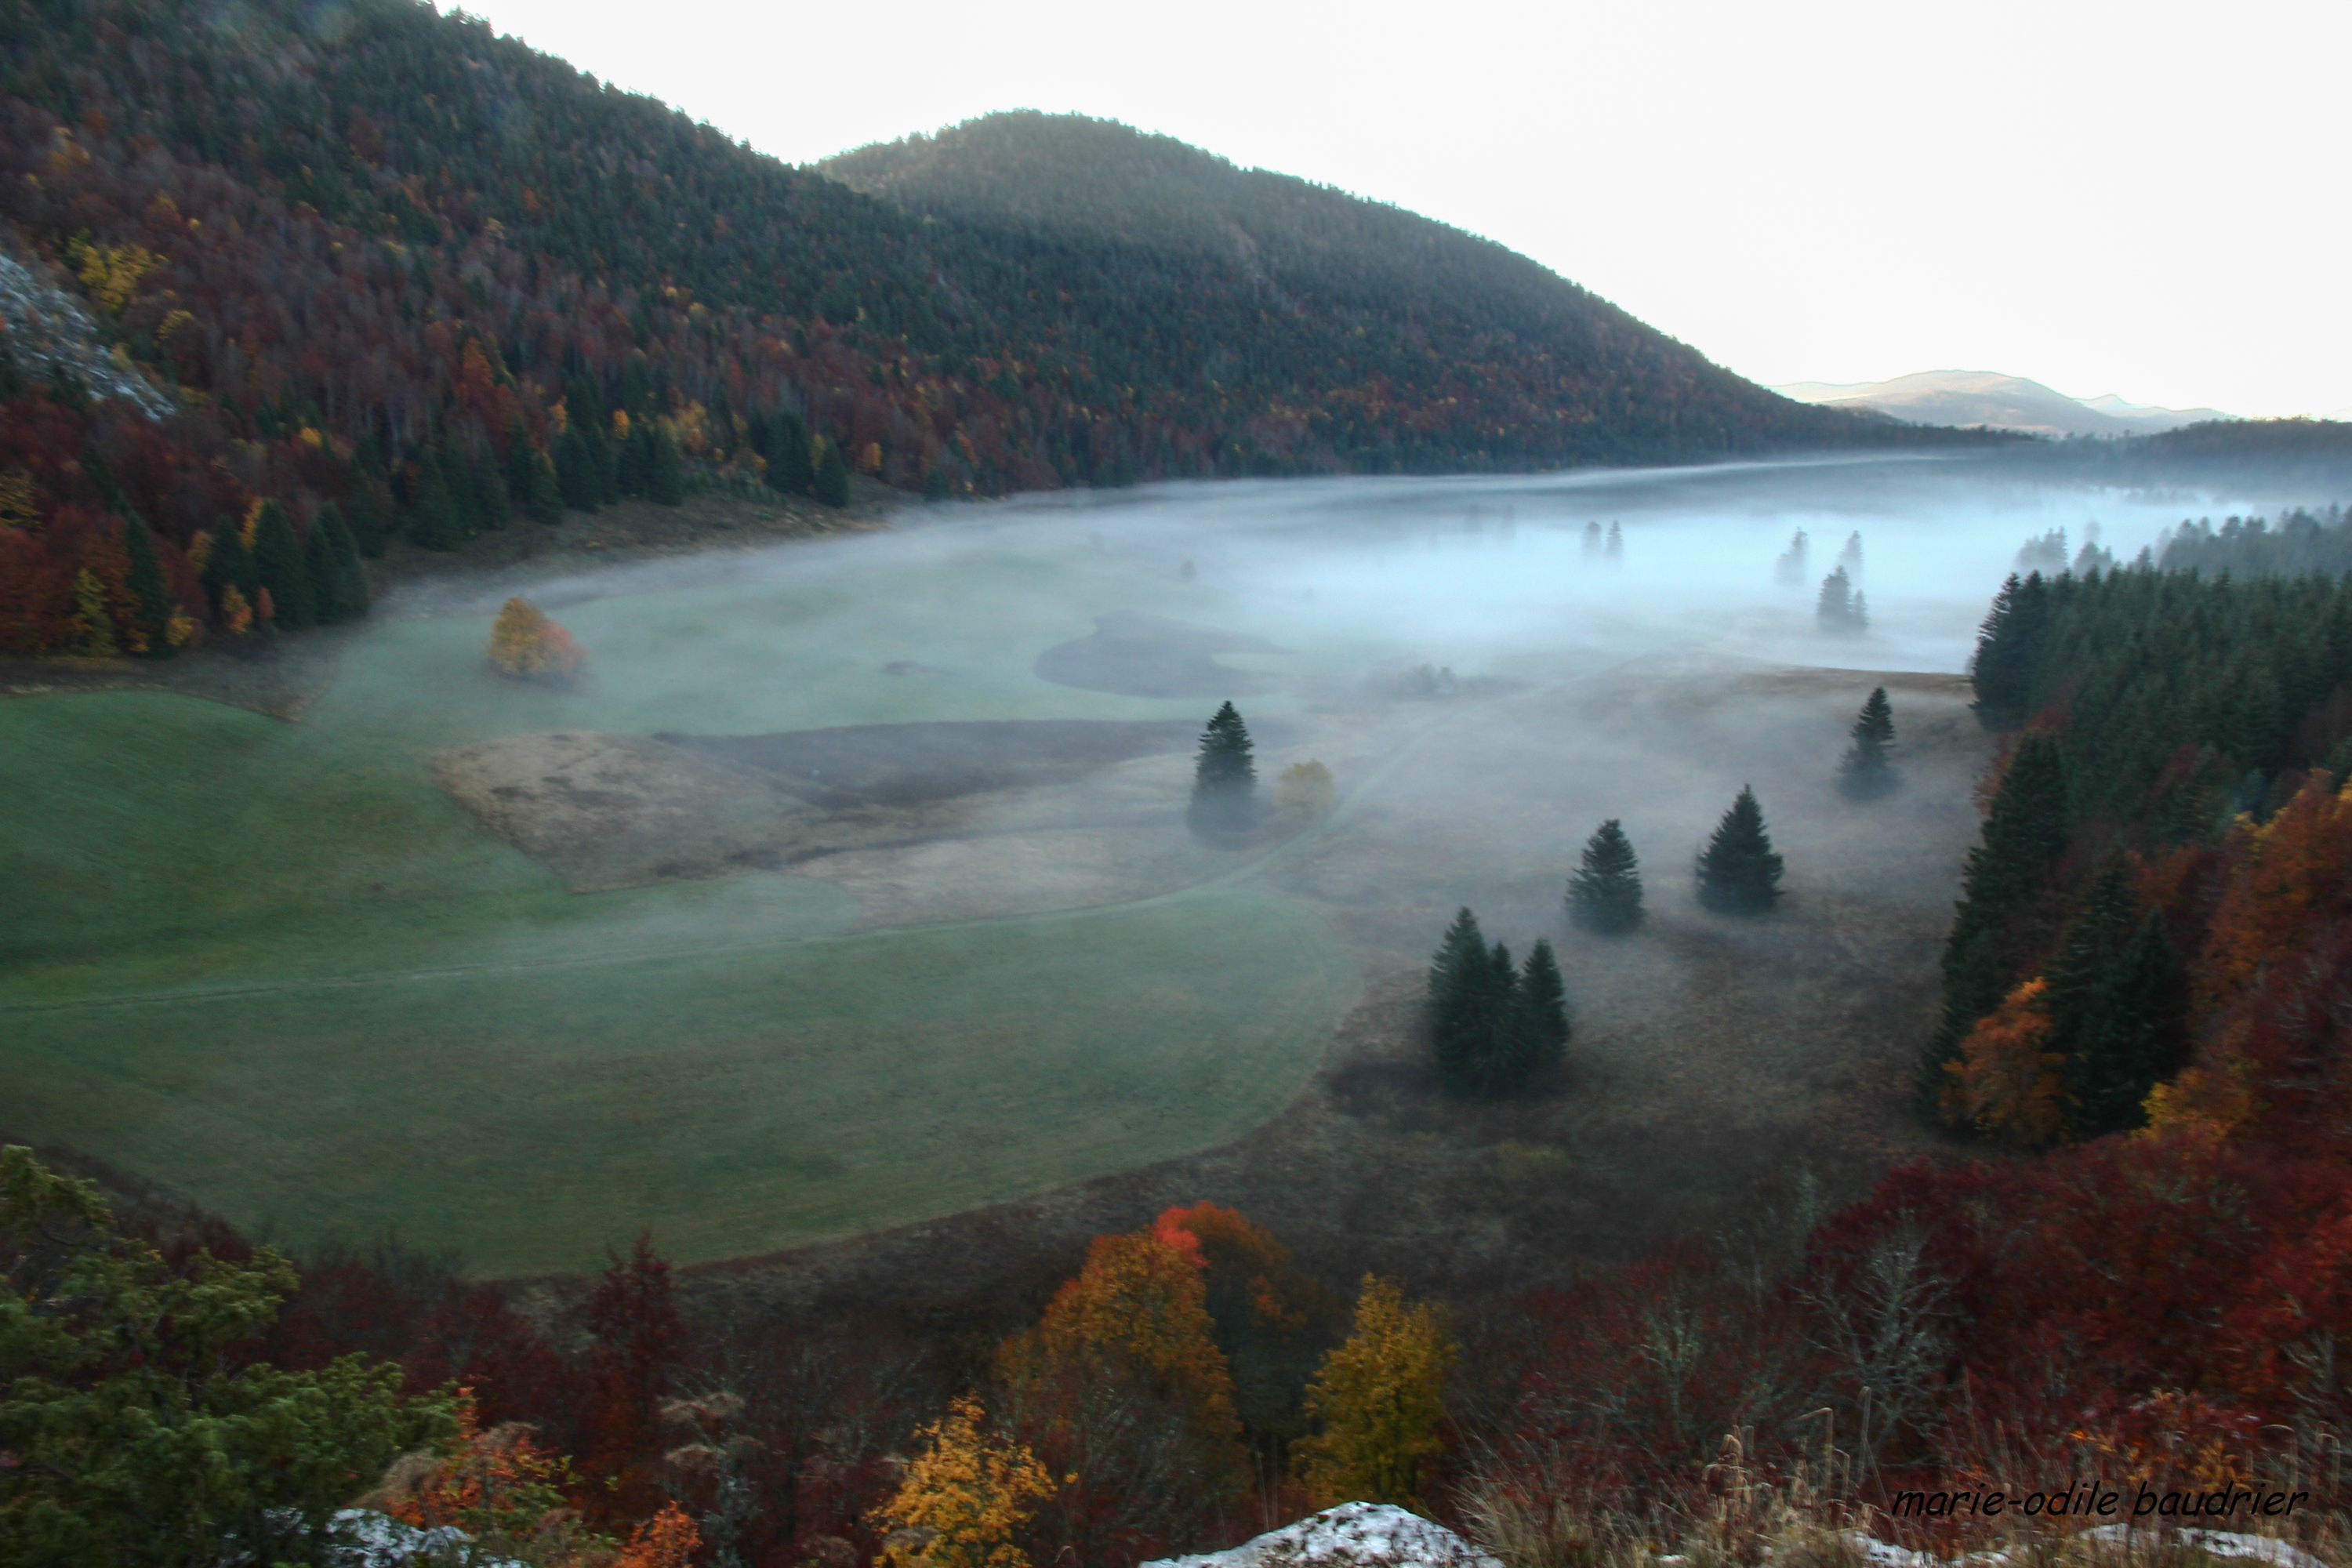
{"left": 468, "top": 0, "right": 2352, "bottom": 416}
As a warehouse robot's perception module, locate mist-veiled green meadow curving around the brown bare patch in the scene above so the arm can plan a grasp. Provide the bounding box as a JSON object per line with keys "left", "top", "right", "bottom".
{"left": 0, "top": 540, "right": 1357, "bottom": 1274}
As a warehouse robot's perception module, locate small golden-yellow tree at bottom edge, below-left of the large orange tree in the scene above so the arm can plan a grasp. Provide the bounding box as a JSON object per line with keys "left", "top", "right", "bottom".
{"left": 868, "top": 1396, "right": 1054, "bottom": 1568}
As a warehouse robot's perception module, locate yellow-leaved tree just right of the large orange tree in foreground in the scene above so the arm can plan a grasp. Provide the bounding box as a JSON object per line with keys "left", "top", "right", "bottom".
{"left": 1296, "top": 1274, "right": 1461, "bottom": 1512}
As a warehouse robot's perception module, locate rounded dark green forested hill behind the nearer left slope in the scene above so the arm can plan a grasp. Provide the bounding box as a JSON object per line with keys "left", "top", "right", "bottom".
{"left": 816, "top": 111, "right": 1938, "bottom": 470}
